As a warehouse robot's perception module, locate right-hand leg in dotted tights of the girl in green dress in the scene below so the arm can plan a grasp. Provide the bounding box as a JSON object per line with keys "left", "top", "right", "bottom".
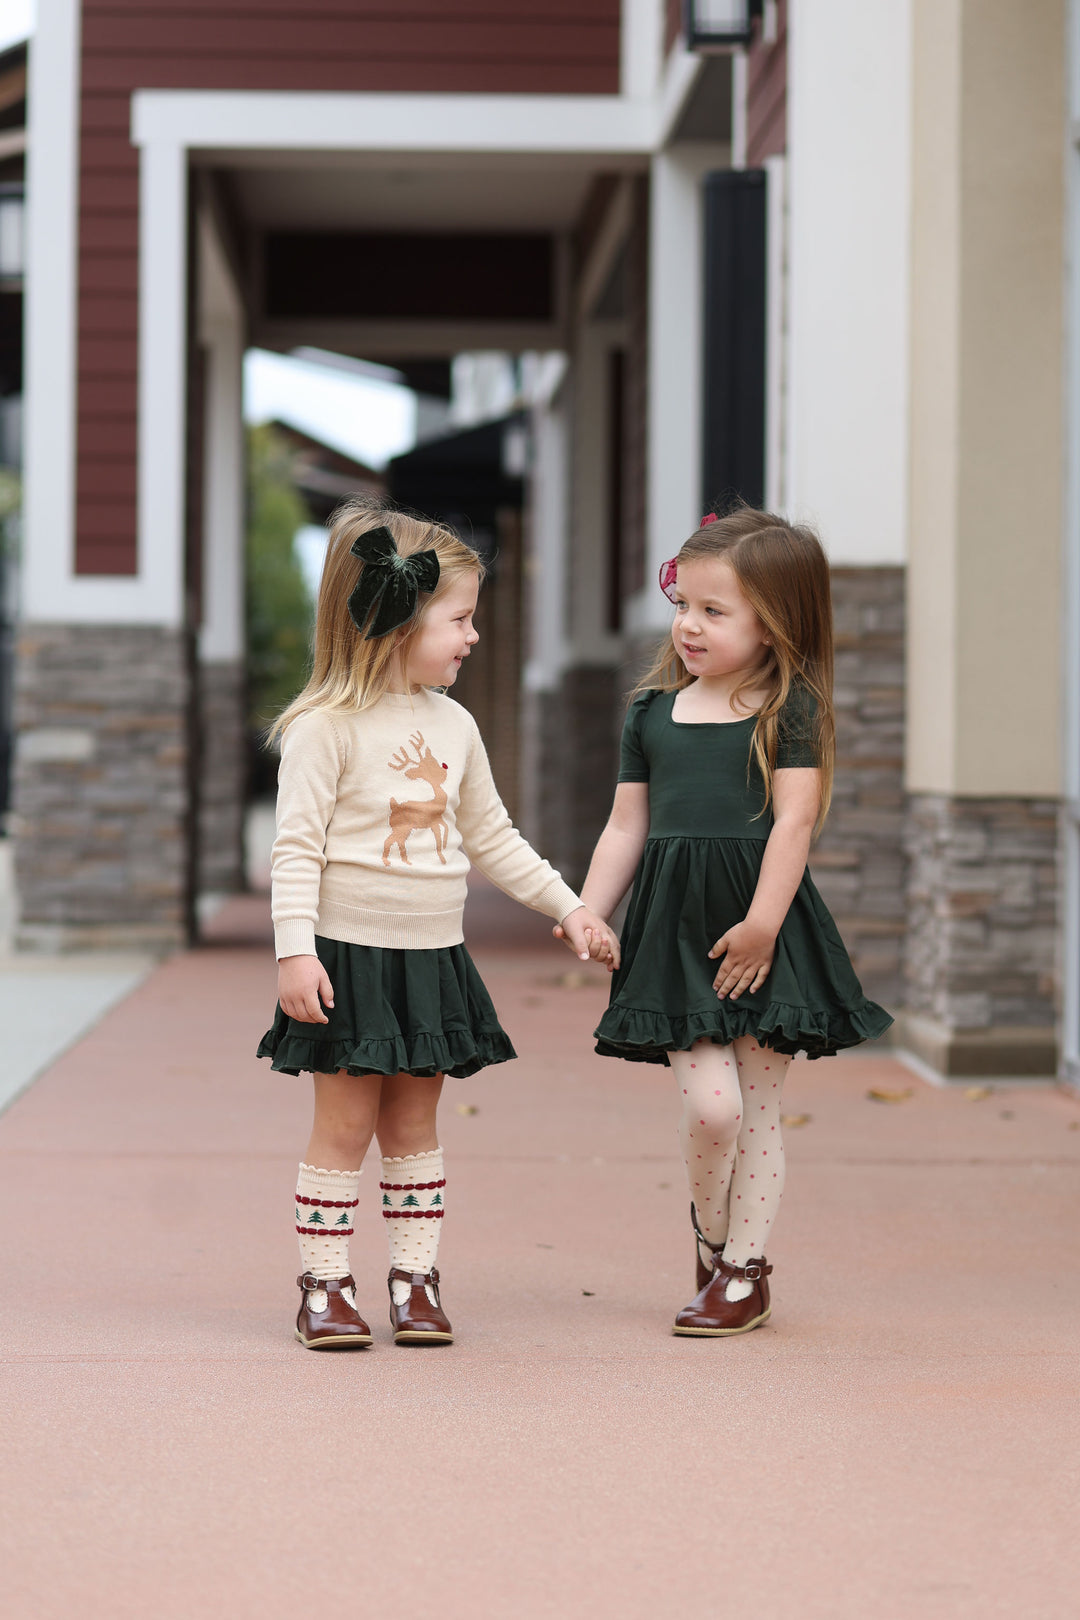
{"left": 724, "top": 1037, "right": 792, "bottom": 1299}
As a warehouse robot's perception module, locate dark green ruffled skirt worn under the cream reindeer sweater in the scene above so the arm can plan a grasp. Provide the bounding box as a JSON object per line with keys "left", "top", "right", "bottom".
{"left": 259, "top": 936, "right": 517, "bottom": 1079}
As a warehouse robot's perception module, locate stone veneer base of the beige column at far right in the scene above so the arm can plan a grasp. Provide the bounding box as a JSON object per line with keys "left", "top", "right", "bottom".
{"left": 905, "top": 794, "right": 1059, "bottom": 1074}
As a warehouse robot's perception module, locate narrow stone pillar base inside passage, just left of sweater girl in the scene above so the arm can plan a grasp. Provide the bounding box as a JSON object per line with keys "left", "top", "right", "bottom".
{"left": 198, "top": 663, "right": 248, "bottom": 894}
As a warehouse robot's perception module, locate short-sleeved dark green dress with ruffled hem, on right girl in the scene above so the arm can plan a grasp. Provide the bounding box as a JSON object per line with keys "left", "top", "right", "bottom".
{"left": 596, "top": 692, "right": 892, "bottom": 1063}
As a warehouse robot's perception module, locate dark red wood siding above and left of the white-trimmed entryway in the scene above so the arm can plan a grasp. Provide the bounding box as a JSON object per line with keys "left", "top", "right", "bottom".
{"left": 76, "top": 0, "right": 620, "bottom": 573}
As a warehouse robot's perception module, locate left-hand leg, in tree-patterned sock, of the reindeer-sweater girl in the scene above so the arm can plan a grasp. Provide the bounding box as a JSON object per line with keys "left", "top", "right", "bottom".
{"left": 296, "top": 1069, "right": 382, "bottom": 1311}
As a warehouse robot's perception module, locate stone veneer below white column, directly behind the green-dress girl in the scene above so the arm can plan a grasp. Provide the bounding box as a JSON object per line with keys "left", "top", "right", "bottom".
{"left": 810, "top": 567, "right": 907, "bottom": 1014}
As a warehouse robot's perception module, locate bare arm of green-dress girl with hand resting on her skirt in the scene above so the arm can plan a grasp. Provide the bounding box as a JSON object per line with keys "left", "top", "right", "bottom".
{"left": 709, "top": 766, "right": 821, "bottom": 1001}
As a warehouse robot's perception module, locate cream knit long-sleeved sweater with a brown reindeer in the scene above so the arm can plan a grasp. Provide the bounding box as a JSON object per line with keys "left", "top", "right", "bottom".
{"left": 272, "top": 689, "right": 581, "bottom": 957}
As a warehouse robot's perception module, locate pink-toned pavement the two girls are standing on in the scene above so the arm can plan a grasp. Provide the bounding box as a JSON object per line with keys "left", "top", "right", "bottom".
{"left": 0, "top": 893, "right": 1080, "bottom": 1620}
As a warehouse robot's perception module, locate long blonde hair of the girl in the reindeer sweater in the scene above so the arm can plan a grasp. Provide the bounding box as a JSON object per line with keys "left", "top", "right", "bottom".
{"left": 267, "top": 496, "right": 484, "bottom": 742}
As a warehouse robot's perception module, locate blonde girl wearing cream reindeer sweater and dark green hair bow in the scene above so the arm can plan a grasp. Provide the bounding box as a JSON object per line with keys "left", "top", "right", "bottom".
{"left": 259, "top": 501, "right": 617, "bottom": 1349}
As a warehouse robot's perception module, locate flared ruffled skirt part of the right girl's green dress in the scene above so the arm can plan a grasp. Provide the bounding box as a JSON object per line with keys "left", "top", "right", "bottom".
{"left": 596, "top": 838, "right": 892, "bottom": 1063}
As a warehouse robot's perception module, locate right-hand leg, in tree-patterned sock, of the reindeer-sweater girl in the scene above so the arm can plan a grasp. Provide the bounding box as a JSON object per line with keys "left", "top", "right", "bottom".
{"left": 376, "top": 1074, "right": 447, "bottom": 1307}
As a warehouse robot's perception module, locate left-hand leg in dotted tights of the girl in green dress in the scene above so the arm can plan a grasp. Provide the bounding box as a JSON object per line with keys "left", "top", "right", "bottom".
{"left": 667, "top": 1040, "right": 743, "bottom": 1265}
